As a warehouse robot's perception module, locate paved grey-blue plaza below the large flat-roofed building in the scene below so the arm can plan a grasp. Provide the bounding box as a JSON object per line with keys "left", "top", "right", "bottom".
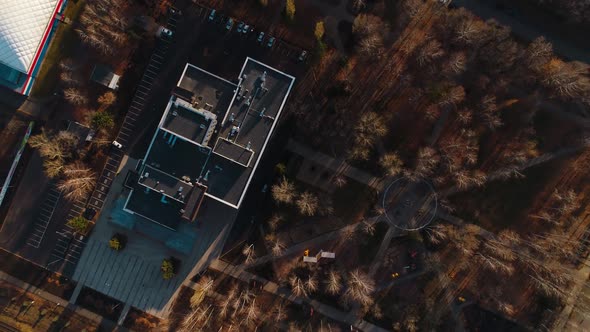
{"left": 73, "top": 160, "right": 237, "bottom": 317}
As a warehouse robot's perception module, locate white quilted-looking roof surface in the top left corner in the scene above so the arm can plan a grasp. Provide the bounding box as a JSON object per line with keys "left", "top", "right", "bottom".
{"left": 0, "top": 0, "right": 62, "bottom": 73}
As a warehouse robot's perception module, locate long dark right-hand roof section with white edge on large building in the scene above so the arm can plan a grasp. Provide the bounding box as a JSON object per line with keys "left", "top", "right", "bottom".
{"left": 207, "top": 58, "right": 295, "bottom": 208}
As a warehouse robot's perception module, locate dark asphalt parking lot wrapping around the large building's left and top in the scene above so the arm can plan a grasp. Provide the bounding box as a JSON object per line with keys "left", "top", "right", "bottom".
{"left": 2, "top": 0, "right": 308, "bottom": 288}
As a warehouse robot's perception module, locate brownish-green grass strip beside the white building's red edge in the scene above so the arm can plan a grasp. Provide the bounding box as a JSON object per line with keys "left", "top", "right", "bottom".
{"left": 31, "top": 0, "right": 86, "bottom": 97}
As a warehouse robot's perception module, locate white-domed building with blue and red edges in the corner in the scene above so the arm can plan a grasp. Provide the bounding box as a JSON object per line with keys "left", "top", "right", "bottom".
{"left": 0, "top": 0, "right": 66, "bottom": 95}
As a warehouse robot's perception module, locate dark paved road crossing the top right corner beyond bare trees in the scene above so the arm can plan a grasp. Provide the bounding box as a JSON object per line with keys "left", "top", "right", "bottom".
{"left": 453, "top": 0, "right": 590, "bottom": 64}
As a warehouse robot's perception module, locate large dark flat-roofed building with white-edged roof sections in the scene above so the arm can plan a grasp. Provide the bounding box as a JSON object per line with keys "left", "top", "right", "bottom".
{"left": 126, "top": 58, "right": 295, "bottom": 229}
